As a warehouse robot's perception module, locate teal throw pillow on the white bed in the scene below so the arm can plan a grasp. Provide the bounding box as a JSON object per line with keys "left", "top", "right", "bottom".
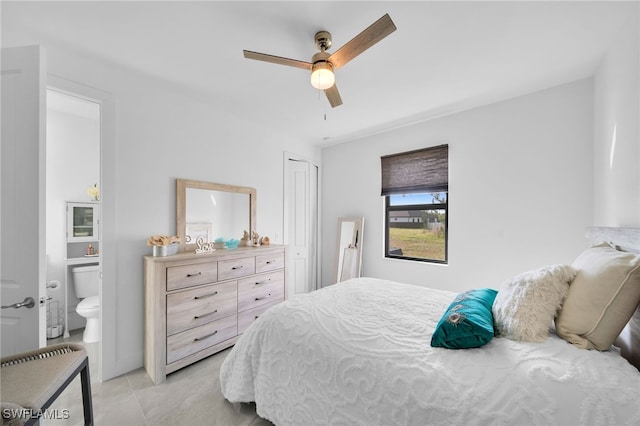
{"left": 431, "top": 288, "right": 498, "bottom": 349}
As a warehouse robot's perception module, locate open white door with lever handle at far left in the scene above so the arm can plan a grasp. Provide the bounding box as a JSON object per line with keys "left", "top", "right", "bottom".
{"left": 0, "top": 46, "right": 47, "bottom": 356}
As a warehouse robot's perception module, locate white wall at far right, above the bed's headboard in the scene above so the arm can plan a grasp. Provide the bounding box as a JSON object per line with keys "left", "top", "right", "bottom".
{"left": 593, "top": 10, "right": 640, "bottom": 227}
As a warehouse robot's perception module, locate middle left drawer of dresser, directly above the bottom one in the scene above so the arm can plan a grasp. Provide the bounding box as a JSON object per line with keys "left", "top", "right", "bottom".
{"left": 167, "top": 281, "right": 238, "bottom": 335}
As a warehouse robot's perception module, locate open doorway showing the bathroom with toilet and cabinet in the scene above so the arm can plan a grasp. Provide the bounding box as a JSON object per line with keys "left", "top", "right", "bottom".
{"left": 46, "top": 87, "right": 101, "bottom": 354}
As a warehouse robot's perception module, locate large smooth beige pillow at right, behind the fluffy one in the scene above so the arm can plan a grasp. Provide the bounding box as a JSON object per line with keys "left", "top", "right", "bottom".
{"left": 556, "top": 243, "right": 640, "bottom": 351}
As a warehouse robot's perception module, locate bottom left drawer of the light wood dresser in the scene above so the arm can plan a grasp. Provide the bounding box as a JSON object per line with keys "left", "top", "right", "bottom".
{"left": 167, "top": 315, "right": 238, "bottom": 364}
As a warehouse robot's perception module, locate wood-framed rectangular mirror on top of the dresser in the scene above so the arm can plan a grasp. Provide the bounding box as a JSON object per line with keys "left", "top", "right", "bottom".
{"left": 176, "top": 179, "right": 256, "bottom": 251}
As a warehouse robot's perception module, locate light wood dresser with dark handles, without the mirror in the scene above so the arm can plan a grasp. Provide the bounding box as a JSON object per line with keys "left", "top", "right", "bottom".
{"left": 144, "top": 245, "right": 287, "bottom": 384}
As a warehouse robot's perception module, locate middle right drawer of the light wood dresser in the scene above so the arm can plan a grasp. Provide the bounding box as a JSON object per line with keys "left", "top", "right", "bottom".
{"left": 238, "top": 271, "right": 284, "bottom": 312}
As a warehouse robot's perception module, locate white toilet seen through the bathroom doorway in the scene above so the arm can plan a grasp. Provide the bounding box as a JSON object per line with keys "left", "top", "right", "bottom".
{"left": 71, "top": 265, "right": 100, "bottom": 343}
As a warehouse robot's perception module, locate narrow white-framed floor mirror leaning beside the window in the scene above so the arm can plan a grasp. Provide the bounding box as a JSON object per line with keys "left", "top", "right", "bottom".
{"left": 335, "top": 217, "right": 364, "bottom": 282}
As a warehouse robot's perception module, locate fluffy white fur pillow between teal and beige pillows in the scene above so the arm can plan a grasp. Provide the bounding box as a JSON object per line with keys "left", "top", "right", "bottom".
{"left": 492, "top": 265, "right": 576, "bottom": 342}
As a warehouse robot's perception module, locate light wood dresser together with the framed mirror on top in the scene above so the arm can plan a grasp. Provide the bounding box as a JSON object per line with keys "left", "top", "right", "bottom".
{"left": 144, "top": 179, "right": 287, "bottom": 384}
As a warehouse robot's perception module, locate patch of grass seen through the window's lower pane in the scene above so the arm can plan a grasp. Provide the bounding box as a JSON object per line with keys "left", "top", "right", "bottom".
{"left": 389, "top": 227, "right": 446, "bottom": 261}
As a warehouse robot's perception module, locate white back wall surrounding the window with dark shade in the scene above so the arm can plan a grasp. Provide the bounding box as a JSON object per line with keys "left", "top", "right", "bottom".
{"left": 322, "top": 79, "right": 593, "bottom": 291}
